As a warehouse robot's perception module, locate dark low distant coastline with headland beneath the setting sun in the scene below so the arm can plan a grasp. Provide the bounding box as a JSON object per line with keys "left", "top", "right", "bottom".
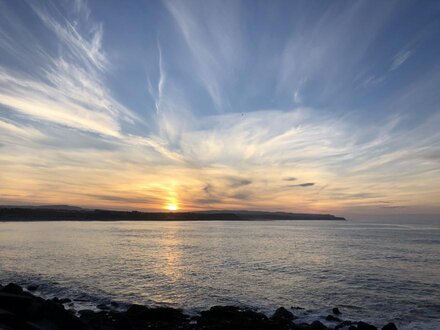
{"left": 0, "top": 205, "right": 346, "bottom": 221}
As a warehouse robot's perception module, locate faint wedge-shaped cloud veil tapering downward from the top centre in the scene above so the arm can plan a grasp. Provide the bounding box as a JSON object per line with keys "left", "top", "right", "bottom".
{"left": 164, "top": 1, "right": 244, "bottom": 110}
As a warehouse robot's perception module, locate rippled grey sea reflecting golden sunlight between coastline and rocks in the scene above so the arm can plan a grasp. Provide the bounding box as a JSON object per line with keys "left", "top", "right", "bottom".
{"left": 0, "top": 220, "right": 440, "bottom": 329}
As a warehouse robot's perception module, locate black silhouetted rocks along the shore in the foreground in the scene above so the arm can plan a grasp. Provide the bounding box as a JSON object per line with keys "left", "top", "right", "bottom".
{"left": 0, "top": 283, "right": 397, "bottom": 330}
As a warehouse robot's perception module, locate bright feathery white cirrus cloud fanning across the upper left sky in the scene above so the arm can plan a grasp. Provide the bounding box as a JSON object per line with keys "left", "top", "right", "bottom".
{"left": 0, "top": 3, "right": 138, "bottom": 137}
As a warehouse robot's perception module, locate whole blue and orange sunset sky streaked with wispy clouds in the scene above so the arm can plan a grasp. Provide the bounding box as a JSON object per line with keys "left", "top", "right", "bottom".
{"left": 0, "top": 0, "right": 440, "bottom": 216}
